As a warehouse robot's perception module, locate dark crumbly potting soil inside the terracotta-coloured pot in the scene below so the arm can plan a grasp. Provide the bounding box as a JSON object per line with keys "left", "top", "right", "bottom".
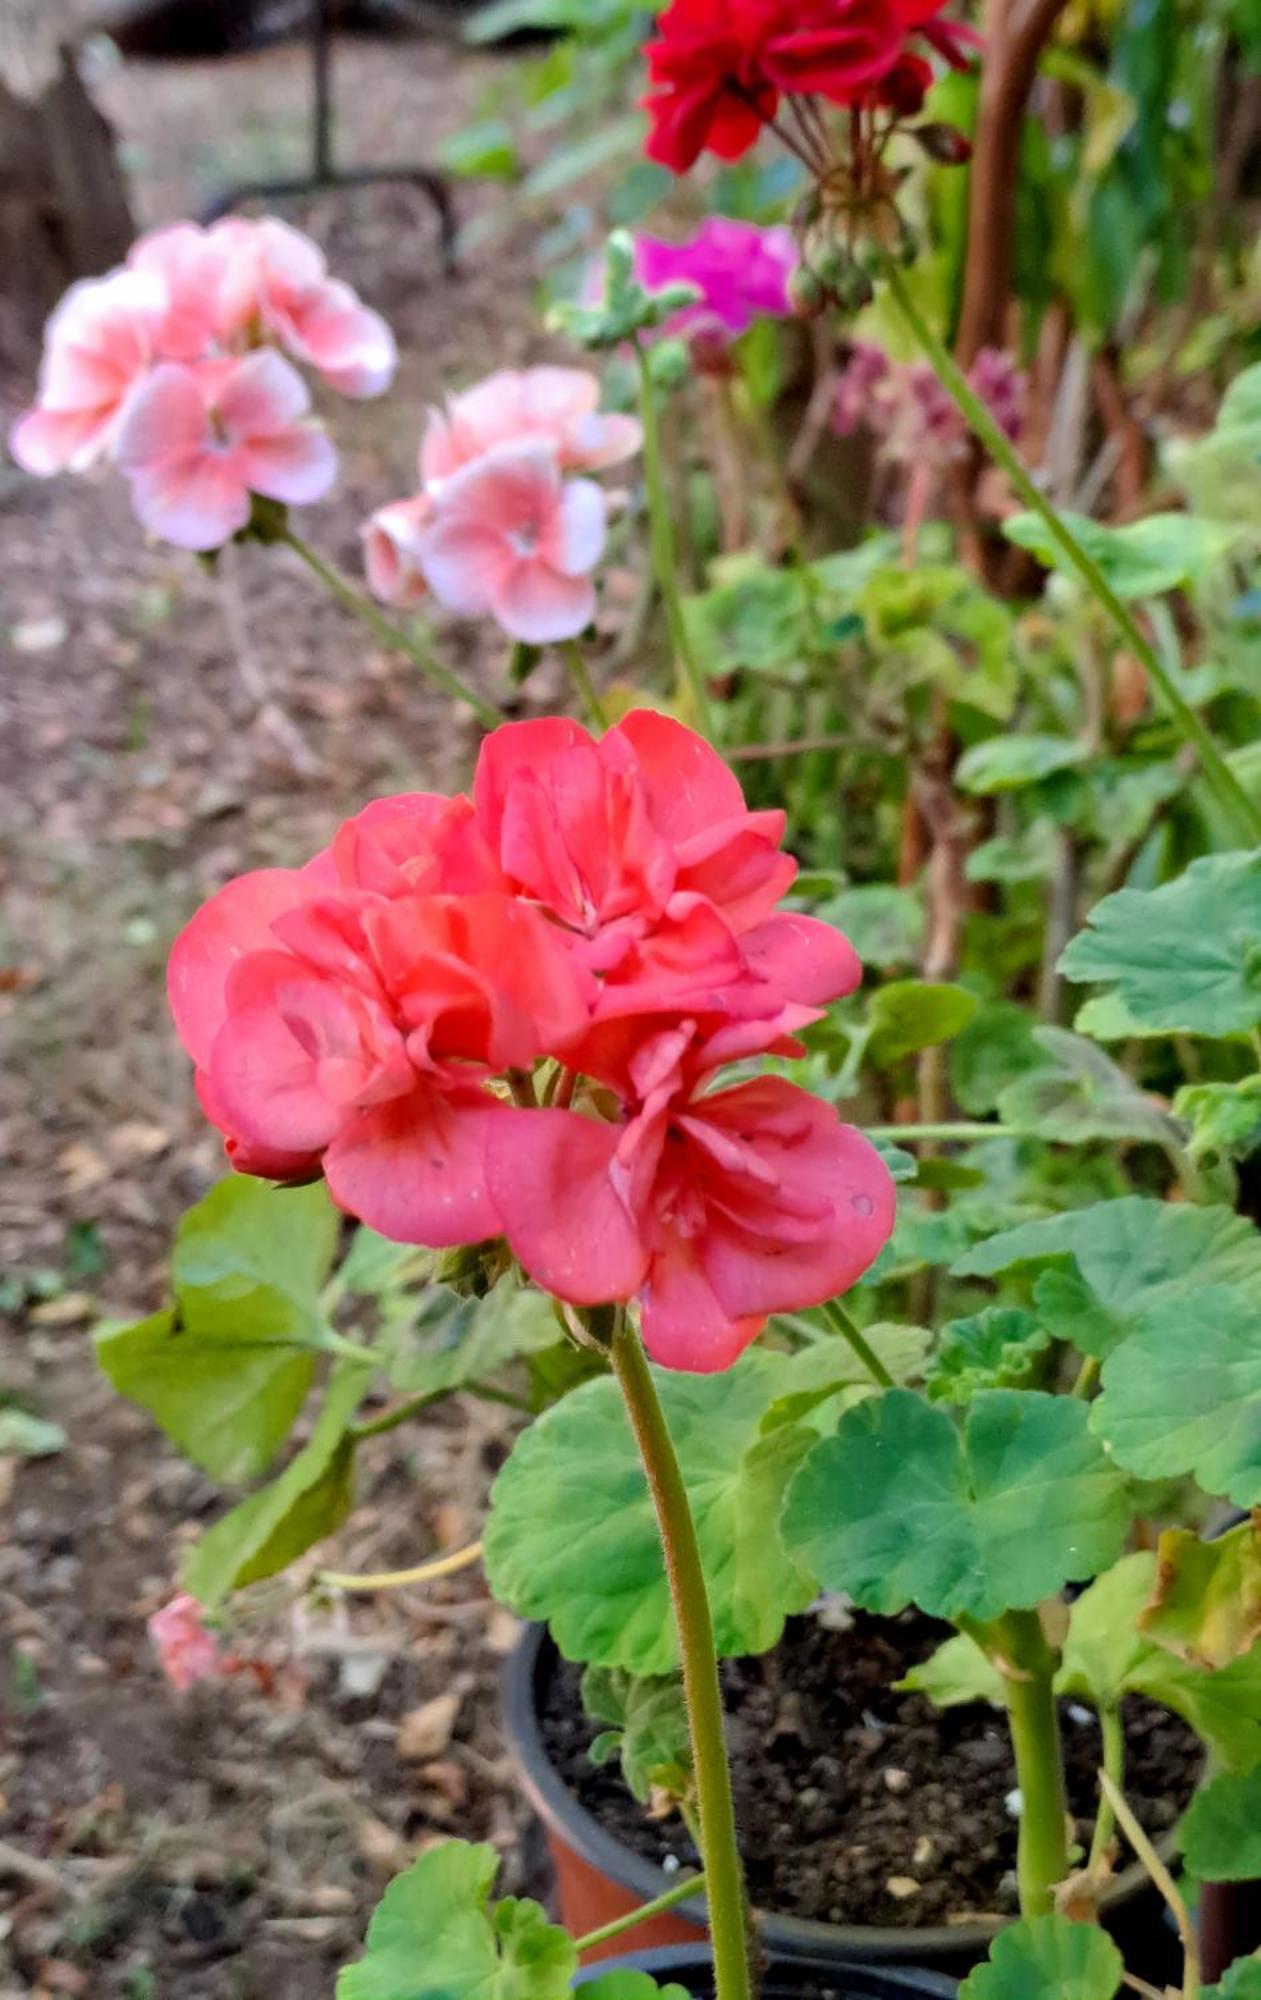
{"left": 540, "top": 1612, "right": 1203, "bottom": 1928}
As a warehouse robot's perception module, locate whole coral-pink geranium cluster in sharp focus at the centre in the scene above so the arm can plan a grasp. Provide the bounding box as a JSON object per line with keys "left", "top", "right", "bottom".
{"left": 170, "top": 712, "right": 893, "bottom": 1370}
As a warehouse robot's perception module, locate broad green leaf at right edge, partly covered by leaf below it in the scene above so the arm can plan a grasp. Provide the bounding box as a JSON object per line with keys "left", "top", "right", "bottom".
{"left": 953, "top": 1194, "right": 1261, "bottom": 1358}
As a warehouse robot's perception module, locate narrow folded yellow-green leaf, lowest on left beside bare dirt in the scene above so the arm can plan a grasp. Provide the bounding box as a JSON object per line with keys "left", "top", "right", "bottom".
{"left": 184, "top": 1362, "right": 374, "bottom": 1610}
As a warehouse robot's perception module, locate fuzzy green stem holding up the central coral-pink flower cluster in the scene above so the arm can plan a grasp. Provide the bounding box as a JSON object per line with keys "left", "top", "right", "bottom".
{"left": 610, "top": 1310, "right": 753, "bottom": 2000}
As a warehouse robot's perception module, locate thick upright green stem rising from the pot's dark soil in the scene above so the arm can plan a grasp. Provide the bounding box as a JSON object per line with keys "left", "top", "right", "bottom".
{"left": 981, "top": 1612, "right": 1069, "bottom": 1916}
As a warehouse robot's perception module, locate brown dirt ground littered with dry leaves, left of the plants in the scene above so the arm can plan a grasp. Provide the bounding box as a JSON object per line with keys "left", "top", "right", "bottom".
{"left": 0, "top": 27, "right": 564, "bottom": 2000}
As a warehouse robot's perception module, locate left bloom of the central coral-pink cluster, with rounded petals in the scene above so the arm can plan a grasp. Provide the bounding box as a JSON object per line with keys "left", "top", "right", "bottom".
{"left": 168, "top": 856, "right": 590, "bottom": 1248}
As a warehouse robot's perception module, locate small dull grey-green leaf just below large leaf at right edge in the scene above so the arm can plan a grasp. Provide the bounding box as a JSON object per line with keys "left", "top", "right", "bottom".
{"left": 999, "top": 1028, "right": 1181, "bottom": 1146}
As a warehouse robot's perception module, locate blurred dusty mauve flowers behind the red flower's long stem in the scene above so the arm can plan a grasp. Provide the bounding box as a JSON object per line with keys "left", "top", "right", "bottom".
{"left": 833, "top": 340, "right": 1025, "bottom": 466}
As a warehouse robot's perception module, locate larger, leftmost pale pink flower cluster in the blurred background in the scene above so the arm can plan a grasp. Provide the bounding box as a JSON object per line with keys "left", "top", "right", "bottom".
{"left": 10, "top": 218, "right": 396, "bottom": 550}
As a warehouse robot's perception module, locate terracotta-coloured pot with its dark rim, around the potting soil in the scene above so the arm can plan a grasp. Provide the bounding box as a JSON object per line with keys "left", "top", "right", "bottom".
{"left": 504, "top": 1626, "right": 1181, "bottom": 1992}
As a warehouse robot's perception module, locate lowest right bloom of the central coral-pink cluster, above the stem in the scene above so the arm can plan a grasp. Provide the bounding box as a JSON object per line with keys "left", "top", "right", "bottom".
{"left": 488, "top": 1026, "right": 895, "bottom": 1372}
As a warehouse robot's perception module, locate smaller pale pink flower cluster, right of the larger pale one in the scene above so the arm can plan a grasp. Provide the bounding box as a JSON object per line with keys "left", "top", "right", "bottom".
{"left": 364, "top": 366, "right": 641, "bottom": 646}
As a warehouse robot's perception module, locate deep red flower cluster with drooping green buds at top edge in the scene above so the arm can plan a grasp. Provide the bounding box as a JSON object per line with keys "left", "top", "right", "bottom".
{"left": 643, "top": 0, "right": 977, "bottom": 312}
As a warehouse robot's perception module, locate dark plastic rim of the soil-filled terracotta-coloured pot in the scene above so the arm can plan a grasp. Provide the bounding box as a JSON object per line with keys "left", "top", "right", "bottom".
{"left": 502, "top": 1624, "right": 1151, "bottom": 1960}
